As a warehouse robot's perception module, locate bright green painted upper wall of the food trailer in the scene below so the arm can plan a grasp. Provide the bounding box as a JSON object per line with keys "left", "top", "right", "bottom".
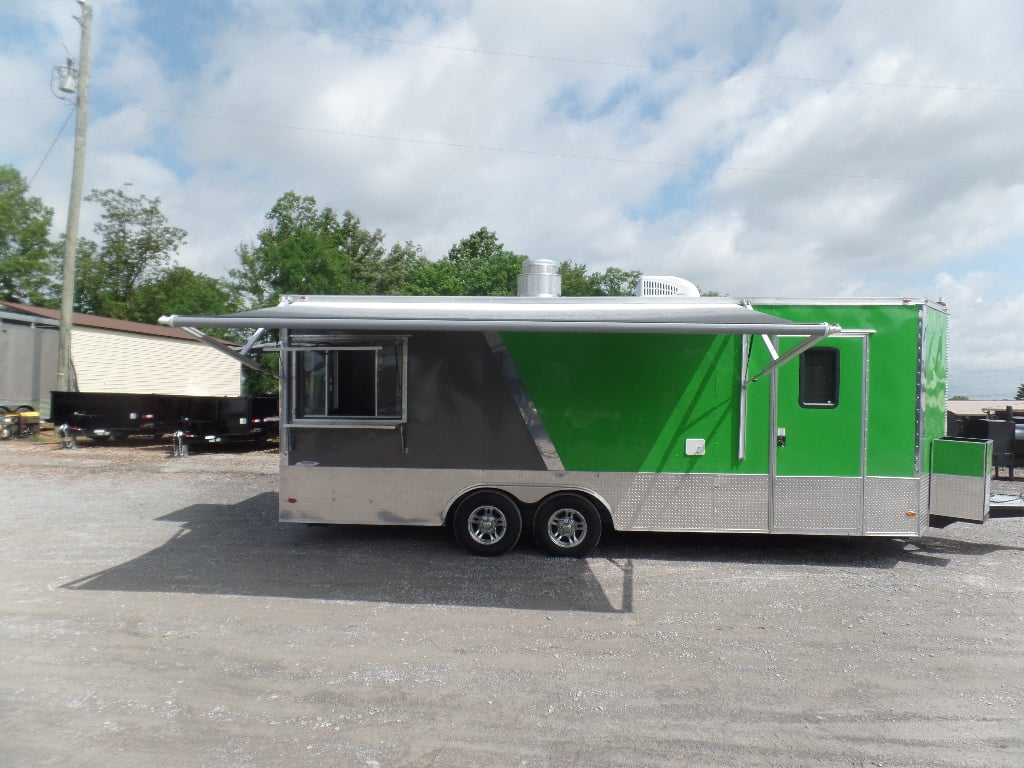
{"left": 495, "top": 303, "right": 946, "bottom": 477}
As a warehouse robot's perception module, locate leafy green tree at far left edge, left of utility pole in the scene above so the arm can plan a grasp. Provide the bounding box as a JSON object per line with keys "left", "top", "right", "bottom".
{"left": 0, "top": 166, "right": 62, "bottom": 306}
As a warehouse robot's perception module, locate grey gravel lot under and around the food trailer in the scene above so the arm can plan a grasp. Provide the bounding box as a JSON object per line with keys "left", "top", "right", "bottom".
{"left": 0, "top": 440, "right": 1024, "bottom": 768}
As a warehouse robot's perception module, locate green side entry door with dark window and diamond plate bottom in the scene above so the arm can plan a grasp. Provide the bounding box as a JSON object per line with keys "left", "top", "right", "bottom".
{"left": 770, "top": 335, "right": 867, "bottom": 534}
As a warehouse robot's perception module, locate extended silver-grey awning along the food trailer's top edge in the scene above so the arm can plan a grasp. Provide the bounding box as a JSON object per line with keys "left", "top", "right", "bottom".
{"left": 160, "top": 296, "right": 841, "bottom": 337}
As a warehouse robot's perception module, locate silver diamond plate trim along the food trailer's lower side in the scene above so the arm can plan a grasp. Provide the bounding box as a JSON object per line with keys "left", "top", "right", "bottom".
{"left": 280, "top": 467, "right": 928, "bottom": 536}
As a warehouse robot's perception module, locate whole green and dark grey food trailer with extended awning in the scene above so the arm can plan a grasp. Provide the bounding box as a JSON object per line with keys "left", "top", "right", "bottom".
{"left": 162, "top": 274, "right": 991, "bottom": 556}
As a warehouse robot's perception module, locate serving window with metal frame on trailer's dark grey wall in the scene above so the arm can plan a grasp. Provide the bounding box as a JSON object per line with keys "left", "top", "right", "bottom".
{"left": 286, "top": 336, "right": 408, "bottom": 426}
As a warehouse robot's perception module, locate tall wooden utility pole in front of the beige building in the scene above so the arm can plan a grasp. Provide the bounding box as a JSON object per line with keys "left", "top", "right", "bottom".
{"left": 57, "top": 0, "right": 92, "bottom": 392}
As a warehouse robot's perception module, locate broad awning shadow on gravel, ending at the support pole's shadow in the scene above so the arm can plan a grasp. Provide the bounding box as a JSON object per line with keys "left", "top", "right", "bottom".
{"left": 62, "top": 493, "right": 623, "bottom": 612}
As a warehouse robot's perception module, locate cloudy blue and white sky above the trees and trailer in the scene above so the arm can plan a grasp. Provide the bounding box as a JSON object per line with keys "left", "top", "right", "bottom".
{"left": 0, "top": 0, "right": 1024, "bottom": 398}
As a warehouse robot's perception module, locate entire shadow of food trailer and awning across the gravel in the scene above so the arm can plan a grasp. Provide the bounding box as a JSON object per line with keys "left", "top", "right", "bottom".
{"left": 63, "top": 493, "right": 1013, "bottom": 613}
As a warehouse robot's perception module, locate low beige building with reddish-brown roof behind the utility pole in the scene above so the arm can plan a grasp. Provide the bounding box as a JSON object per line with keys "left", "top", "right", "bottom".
{"left": 0, "top": 301, "right": 242, "bottom": 421}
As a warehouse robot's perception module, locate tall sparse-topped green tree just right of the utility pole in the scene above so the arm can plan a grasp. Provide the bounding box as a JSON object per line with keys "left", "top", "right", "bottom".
{"left": 76, "top": 189, "right": 187, "bottom": 319}
